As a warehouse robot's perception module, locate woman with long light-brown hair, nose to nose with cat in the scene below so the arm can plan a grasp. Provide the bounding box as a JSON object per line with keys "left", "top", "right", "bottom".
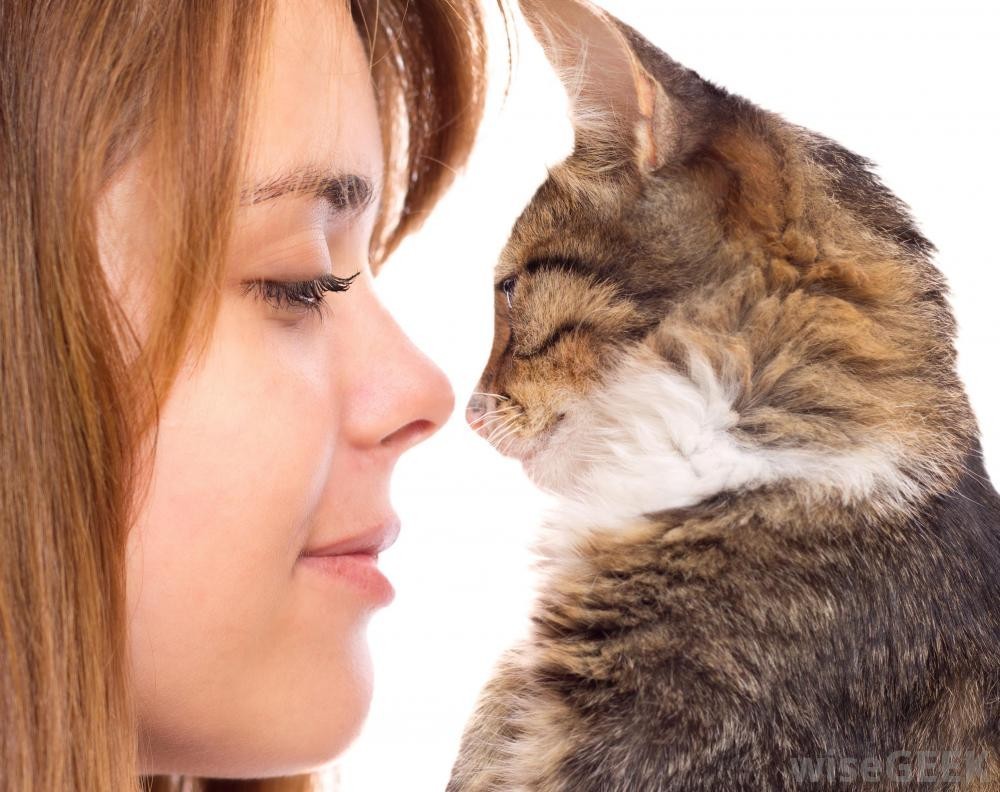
{"left": 0, "top": 0, "right": 496, "bottom": 791}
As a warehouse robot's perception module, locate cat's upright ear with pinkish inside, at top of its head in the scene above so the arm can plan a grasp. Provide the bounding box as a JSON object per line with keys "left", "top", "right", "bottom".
{"left": 520, "top": 0, "right": 672, "bottom": 172}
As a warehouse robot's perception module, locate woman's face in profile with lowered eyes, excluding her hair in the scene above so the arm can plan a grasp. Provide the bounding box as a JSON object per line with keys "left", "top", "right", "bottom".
{"left": 100, "top": 0, "right": 452, "bottom": 777}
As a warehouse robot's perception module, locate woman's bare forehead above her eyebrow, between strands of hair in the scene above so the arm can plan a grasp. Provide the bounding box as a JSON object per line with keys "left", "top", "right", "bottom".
{"left": 248, "top": 0, "right": 383, "bottom": 204}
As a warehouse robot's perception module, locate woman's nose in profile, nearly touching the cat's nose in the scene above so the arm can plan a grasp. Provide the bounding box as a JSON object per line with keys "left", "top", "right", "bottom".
{"left": 345, "top": 294, "right": 455, "bottom": 454}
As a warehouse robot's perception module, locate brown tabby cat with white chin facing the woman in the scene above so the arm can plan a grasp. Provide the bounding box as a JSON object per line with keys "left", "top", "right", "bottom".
{"left": 447, "top": 0, "right": 1000, "bottom": 792}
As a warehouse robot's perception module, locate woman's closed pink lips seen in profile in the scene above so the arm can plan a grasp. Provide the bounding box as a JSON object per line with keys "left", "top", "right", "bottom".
{"left": 299, "top": 515, "right": 399, "bottom": 605}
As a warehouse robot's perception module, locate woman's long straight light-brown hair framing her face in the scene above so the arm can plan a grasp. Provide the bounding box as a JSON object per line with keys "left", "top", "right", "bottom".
{"left": 0, "top": 0, "right": 486, "bottom": 792}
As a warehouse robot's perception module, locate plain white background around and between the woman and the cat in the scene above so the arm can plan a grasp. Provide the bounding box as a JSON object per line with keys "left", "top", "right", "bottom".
{"left": 330, "top": 0, "right": 1000, "bottom": 792}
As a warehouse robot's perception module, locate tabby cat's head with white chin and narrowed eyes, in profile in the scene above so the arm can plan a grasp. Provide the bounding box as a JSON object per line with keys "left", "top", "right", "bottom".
{"left": 467, "top": 0, "right": 973, "bottom": 524}
